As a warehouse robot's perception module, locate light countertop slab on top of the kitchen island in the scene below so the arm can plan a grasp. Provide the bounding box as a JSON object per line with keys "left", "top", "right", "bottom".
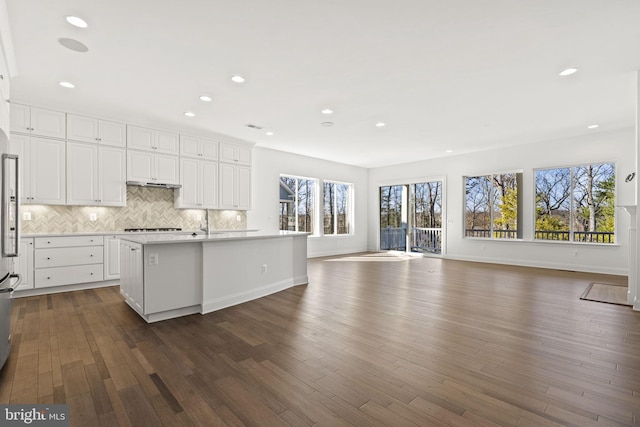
{"left": 120, "top": 230, "right": 311, "bottom": 245}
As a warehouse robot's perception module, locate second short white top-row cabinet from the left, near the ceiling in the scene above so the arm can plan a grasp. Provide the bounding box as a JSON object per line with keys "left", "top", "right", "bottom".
{"left": 67, "top": 114, "right": 127, "bottom": 147}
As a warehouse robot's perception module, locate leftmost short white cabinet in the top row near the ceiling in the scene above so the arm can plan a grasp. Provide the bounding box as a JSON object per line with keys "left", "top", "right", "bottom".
{"left": 11, "top": 104, "right": 66, "bottom": 139}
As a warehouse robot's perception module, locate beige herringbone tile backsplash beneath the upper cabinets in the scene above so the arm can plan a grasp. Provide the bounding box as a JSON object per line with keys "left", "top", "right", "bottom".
{"left": 21, "top": 186, "right": 247, "bottom": 234}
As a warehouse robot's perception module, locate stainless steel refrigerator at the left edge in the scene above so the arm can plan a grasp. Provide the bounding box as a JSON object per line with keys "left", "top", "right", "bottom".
{"left": 0, "top": 129, "right": 20, "bottom": 369}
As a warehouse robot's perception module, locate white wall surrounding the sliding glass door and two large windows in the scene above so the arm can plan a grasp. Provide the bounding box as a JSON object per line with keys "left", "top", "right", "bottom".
{"left": 368, "top": 129, "right": 636, "bottom": 275}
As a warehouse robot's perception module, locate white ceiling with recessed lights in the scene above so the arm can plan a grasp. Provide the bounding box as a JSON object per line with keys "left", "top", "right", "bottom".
{"left": 6, "top": 0, "right": 640, "bottom": 167}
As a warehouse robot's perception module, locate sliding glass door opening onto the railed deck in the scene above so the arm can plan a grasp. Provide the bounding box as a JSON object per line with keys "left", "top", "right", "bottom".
{"left": 379, "top": 180, "right": 443, "bottom": 255}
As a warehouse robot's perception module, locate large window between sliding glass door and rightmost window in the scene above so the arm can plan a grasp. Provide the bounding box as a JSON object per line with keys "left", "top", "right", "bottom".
{"left": 465, "top": 173, "right": 522, "bottom": 239}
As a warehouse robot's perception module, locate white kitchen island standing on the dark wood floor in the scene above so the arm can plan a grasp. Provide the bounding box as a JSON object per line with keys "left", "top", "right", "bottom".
{"left": 120, "top": 231, "right": 309, "bottom": 322}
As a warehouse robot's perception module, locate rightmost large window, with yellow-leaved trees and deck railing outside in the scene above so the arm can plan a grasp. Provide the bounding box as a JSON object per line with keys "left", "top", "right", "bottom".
{"left": 535, "top": 163, "right": 616, "bottom": 243}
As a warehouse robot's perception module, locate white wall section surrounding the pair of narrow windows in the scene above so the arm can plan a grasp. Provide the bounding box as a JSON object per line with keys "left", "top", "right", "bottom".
{"left": 247, "top": 147, "right": 369, "bottom": 257}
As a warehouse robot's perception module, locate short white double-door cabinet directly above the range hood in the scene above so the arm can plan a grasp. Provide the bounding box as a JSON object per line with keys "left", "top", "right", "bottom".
{"left": 127, "top": 150, "right": 180, "bottom": 184}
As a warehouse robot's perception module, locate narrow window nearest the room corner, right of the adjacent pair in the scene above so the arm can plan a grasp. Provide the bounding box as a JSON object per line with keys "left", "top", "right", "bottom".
{"left": 323, "top": 181, "right": 351, "bottom": 236}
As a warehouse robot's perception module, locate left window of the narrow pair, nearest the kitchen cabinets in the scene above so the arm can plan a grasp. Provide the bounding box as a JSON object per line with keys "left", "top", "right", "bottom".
{"left": 280, "top": 175, "right": 318, "bottom": 233}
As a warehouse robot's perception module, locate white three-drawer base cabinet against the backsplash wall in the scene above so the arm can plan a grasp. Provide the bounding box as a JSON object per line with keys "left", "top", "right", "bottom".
{"left": 34, "top": 236, "right": 104, "bottom": 288}
